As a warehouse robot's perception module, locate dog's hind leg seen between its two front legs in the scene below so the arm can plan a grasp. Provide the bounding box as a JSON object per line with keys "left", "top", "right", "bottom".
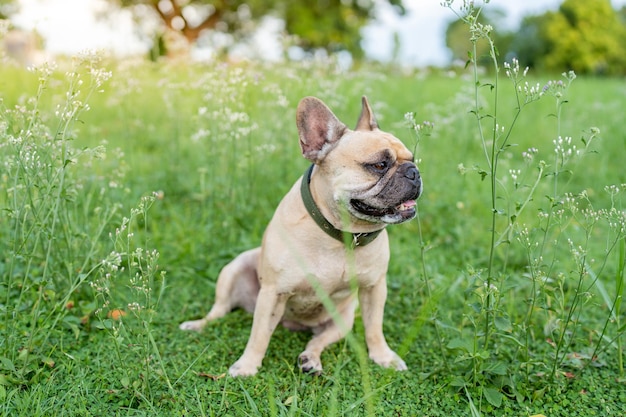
{"left": 298, "top": 301, "right": 356, "bottom": 375}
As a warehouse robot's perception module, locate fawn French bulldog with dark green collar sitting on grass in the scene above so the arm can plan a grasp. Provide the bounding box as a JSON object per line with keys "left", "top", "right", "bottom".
{"left": 180, "top": 97, "right": 422, "bottom": 376}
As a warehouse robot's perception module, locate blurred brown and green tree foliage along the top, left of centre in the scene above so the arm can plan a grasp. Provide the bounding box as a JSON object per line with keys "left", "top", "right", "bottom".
{"left": 111, "top": 0, "right": 405, "bottom": 57}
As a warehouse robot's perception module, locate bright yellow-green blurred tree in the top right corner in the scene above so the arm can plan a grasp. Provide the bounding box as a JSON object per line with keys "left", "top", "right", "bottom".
{"left": 544, "top": 0, "right": 626, "bottom": 74}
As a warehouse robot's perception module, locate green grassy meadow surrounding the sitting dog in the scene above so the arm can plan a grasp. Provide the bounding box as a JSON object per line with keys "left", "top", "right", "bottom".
{"left": 0, "top": 44, "right": 626, "bottom": 416}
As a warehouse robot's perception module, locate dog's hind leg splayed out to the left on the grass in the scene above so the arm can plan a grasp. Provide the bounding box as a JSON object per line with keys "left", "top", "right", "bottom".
{"left": 179, "top": 248, "right": 261, "bottom": 331}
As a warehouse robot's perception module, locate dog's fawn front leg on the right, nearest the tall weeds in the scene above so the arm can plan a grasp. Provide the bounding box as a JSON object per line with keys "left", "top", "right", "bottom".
{"left": 359, "top": 276, "right": 408, "bottom": 371}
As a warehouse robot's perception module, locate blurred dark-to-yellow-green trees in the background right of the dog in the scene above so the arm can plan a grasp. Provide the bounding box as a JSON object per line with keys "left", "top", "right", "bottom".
{"left": 446, "top": 0, "right": 626, "bottom": 75}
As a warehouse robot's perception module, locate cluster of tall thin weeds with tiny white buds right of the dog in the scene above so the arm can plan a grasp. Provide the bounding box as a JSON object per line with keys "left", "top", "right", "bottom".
{"left": 443, "top": 0, "right": 624, "bottom": 406}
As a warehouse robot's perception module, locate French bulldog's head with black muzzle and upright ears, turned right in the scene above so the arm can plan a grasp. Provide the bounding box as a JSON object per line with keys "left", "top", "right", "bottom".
{"left": 296, "top": 97, "right": 422, "bottom": 224}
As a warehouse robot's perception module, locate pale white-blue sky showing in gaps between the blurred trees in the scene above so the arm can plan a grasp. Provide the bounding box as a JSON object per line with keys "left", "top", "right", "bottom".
{"left": 8, "top": 0, "right": 626, "bottom": 66}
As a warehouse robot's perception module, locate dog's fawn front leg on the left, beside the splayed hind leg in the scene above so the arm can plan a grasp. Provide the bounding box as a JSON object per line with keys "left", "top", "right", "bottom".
{"left": 228, "top": 285, "right": 288, "bottom": 376}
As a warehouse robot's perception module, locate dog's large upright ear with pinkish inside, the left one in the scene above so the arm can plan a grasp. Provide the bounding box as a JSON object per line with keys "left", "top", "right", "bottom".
{"left": 296, "top": 97, "right": 346, "bottom": 163}
